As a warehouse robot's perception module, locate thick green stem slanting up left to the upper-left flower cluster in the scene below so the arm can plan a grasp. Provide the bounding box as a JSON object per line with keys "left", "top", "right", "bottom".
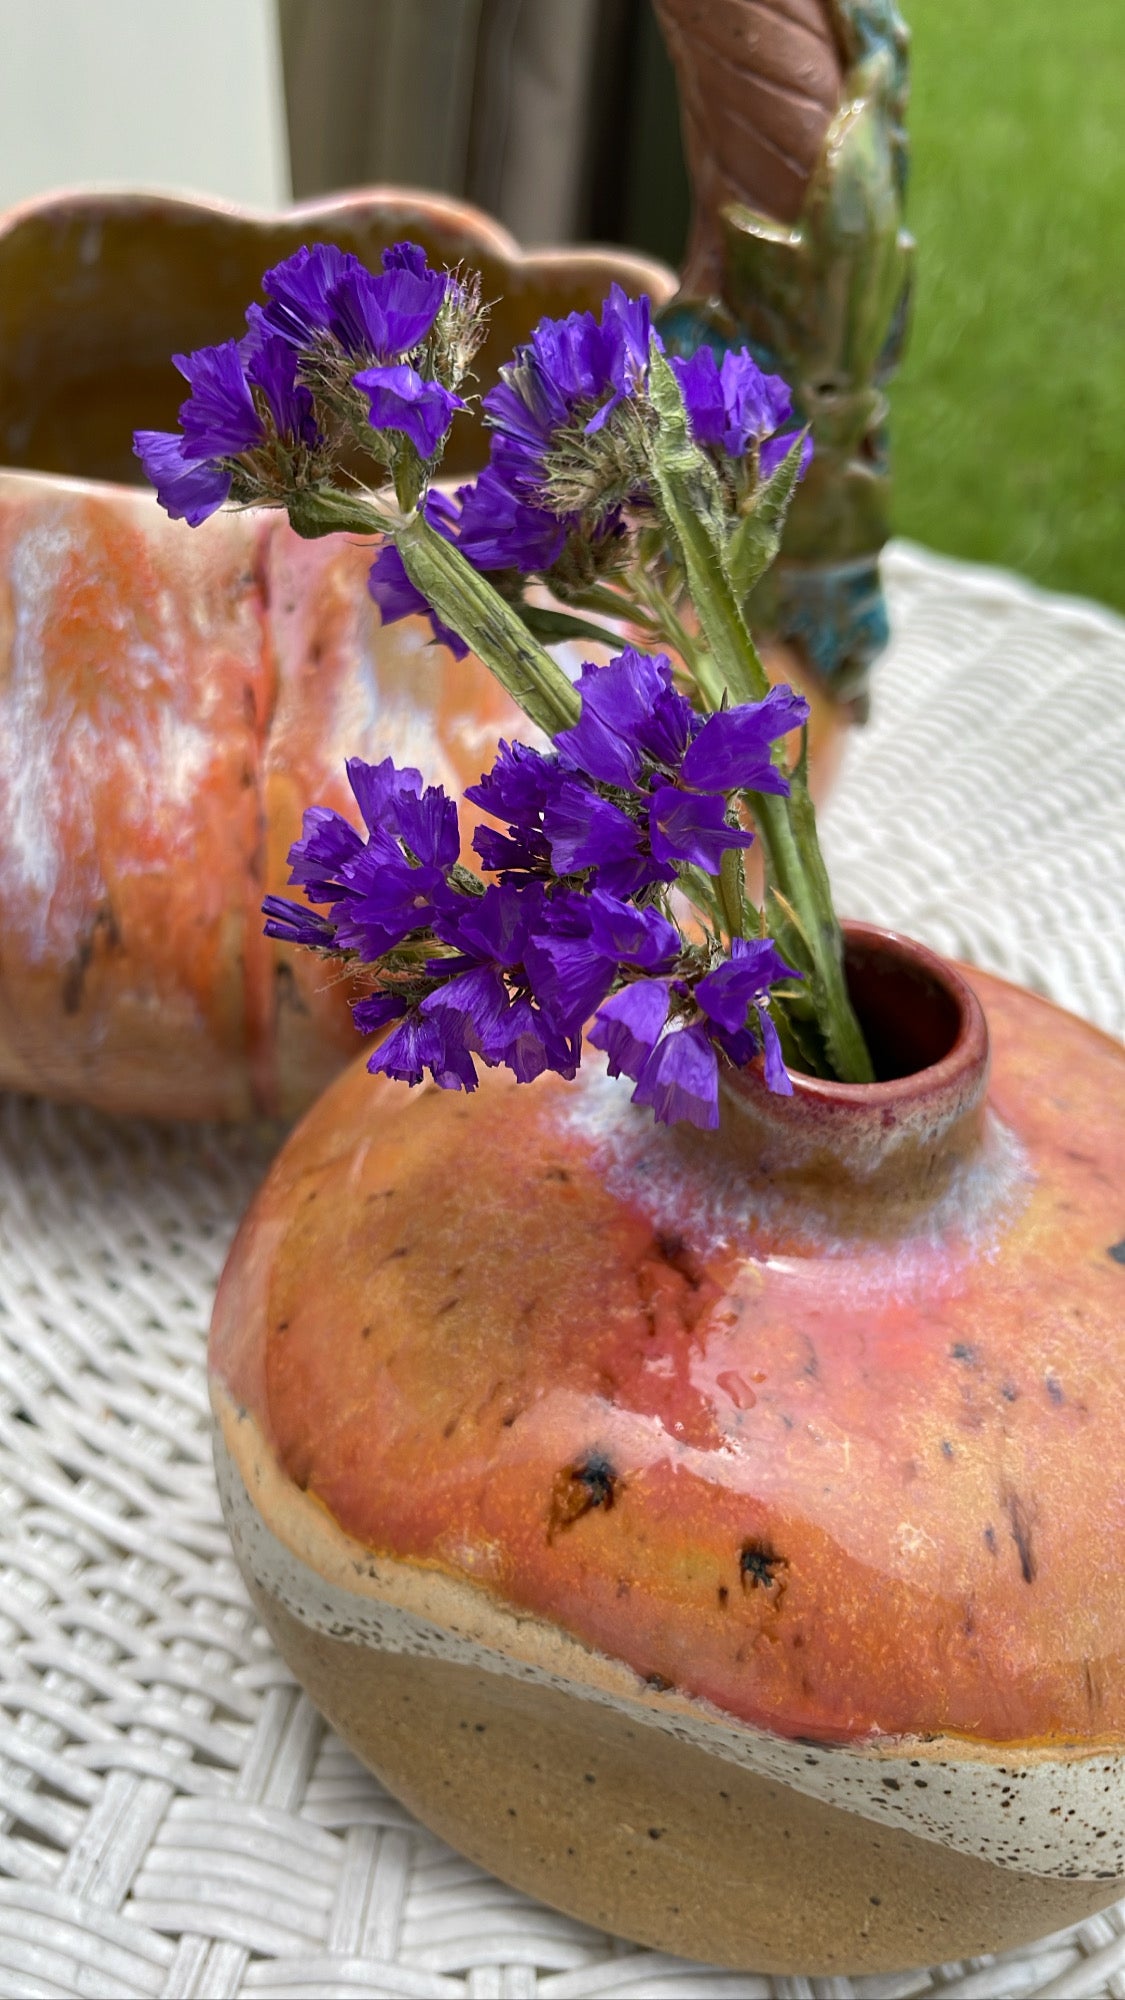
{"left": 288, "top": 488, "right": 583, "bottom": 736}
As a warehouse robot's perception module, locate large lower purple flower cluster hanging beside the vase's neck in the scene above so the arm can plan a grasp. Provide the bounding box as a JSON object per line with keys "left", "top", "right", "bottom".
{"left": 264, "top": 652, "right": 807, "bottom": 1126}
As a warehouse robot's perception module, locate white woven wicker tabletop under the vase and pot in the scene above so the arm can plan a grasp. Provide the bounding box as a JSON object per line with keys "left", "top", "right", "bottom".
{"left": 0, "top": 548, "right": 1125, "bottom": 2000}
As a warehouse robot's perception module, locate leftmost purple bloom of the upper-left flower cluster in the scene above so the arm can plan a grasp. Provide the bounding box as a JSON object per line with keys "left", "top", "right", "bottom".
{"left": 132, "top": 326, "right": 320, "bottom": 528}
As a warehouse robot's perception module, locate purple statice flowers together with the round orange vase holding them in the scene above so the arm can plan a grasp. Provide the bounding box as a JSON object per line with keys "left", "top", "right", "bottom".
{"left": 136, "top": 244, "right": 1125, "bottom": 1972}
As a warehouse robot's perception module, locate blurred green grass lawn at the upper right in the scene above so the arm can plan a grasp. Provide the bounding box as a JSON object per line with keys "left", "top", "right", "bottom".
{"left": 893, "top": 0, "right": 1125, "bottom": 608}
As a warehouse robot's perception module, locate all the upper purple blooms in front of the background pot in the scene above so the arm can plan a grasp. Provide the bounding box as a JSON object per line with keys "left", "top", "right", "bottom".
{"left": 134, "top": 242, "right": 811, "bottom": 684}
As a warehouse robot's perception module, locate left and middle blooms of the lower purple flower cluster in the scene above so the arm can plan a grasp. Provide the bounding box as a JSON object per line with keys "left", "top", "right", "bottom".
{"left": 262, "top": 758, "right": 664, "bottom": 1090}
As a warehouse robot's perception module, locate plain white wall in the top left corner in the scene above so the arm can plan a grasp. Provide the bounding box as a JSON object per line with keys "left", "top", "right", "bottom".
{"left": 0, "top": 0, "right": 290, "bottom": 210}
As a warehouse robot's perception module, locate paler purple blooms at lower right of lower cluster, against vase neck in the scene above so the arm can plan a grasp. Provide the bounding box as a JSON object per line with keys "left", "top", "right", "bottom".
{"left": 589, "top": 938, "right": 801, "bottom": 1130}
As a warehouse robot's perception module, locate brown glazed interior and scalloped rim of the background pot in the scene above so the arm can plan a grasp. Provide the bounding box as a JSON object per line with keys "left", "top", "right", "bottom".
{"left": 0, "top": 188, "right": 675, "bottom": 484}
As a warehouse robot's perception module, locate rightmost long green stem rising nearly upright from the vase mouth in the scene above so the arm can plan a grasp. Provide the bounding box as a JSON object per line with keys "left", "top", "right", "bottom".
{"left": 649, "top": 346, "right": 875, "bottom": 1084}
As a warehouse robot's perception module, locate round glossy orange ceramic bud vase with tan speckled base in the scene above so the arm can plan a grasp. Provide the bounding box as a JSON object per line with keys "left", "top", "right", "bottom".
{"left": 210, "top": 926, "right": 1125, "bottom": 1974}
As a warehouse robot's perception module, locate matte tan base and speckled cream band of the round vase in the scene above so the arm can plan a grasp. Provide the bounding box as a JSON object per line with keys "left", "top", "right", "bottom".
{"left": 214, "top": 1388, "right": 1125, "bottom": 1974}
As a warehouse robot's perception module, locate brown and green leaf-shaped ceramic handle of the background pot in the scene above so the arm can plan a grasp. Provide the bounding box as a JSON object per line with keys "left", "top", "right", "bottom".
{"left": 657, "top": 0, "right": 913, "bottom": 696}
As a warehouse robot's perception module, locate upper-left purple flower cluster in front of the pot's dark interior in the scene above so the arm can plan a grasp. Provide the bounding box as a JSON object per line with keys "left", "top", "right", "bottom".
{"left": 134, "top": 244, "right": 464, "bottom": 528}
